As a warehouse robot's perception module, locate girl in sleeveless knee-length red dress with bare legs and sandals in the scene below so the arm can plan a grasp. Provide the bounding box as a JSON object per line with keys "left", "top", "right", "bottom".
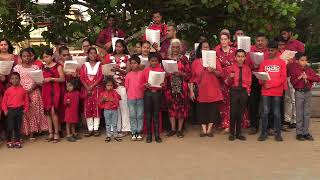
{"left": 42, "top": 49, "right": 65, "bottom": 143}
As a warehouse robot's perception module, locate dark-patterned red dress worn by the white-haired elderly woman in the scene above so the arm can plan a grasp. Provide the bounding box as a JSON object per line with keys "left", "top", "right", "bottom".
{"left": 164, "top": 56, "right": 191, "bottom": 119}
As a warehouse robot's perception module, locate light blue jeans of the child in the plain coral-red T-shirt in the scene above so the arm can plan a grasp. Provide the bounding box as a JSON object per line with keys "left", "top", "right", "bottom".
{"left": 128, "top": 99, "right": 143, "bottom": 134}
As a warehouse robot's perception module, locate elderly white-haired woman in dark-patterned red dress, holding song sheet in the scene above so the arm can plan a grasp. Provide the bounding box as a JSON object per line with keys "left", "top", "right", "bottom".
{"left": 165, "top": 39, "right": 191, "bottom": 138}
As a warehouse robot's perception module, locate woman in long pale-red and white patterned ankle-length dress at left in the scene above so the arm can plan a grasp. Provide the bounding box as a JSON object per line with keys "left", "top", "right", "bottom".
{"left": 13, "top": 49, "right": 48, "bottom": 140}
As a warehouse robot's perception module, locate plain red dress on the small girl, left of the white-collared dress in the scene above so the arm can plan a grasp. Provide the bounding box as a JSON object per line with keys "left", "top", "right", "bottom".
{"left": 64, "top": 91, "right": 80, "bottom": 123}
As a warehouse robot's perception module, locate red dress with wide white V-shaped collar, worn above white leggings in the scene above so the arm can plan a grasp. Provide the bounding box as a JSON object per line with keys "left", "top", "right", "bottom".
{"left": 80, "top": 62, "right": 103, "bottom": 118}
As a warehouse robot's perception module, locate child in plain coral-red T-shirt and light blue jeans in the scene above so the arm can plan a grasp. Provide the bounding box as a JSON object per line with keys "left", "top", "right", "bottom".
{"left": 125, "top": 55, "right": 143, "bottom": 141}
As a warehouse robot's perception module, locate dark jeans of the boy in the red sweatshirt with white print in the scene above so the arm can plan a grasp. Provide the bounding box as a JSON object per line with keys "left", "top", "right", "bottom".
{"left": 261, "top": 96, "right": 281, "bottom": 136}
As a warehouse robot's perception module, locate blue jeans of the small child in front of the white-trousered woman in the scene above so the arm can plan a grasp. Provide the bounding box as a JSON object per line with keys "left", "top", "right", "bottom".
{"left": 103, "top": 109, "right": 118, "bottom": 137}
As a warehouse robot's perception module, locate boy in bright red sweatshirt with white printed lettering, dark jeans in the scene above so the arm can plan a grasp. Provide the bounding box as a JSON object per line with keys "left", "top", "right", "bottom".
{"left": 258, "top": 42, "right": 287, "bottom": 141}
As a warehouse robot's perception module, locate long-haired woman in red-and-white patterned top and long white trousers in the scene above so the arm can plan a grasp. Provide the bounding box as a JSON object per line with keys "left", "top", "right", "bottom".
{"left": 103, "top": 39, "right": 131, "bottom": 136}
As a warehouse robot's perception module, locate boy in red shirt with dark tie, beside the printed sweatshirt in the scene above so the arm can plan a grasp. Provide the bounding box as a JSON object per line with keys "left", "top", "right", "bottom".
{"left": 226, "top": 49, "right": 251, "bottom": 141}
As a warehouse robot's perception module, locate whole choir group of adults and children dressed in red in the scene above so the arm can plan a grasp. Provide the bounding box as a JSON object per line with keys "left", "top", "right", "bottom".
{"left": 0, "top": 11, "right": 320, "bottom": 148}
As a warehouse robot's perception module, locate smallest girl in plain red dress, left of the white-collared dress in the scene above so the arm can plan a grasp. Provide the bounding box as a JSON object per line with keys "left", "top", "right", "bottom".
{"left": 63, "top": 79, "right": 81, "bottom": 142}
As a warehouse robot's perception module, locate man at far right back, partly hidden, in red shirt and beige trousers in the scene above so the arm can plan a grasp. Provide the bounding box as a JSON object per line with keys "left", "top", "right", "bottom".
{"left": 280, "top": 28, "right": 305, "bottom": 128}
